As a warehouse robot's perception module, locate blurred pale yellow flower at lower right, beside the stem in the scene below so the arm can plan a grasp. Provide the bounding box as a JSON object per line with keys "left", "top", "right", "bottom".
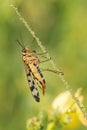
{"left": 52, "top": 88, "right": 87, "bottom": 126}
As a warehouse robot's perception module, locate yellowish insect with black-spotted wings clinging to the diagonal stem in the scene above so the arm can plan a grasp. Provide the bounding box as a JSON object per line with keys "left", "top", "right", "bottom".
{"left": 17, "top": 40, "right": 46, "bottom": 102}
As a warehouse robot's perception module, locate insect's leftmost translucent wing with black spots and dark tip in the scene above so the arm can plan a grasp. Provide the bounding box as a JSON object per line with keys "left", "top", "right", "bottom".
{"left": 24, "top": 63, "right": 40, "bottom": 102}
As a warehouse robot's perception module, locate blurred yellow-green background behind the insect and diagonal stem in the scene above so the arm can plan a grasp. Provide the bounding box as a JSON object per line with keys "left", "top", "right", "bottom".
{"left": 0, "top": 0, "right": 87, "bottom": 130}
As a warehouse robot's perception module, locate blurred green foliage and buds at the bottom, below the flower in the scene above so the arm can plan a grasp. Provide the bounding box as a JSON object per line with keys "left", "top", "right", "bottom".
{"left": 27, "top": 110, "right": 70, "bottom": 130}
